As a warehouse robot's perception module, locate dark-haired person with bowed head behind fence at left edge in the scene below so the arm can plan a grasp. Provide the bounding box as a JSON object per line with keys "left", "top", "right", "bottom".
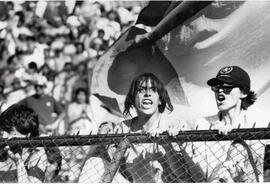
{"left": 0, "top": 104, "right": 47, "bottom": 183}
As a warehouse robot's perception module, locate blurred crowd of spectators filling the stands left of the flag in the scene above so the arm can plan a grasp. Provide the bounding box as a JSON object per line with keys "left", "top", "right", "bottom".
{"left": 0, "top": 1, "right": 141, "bottom": 182}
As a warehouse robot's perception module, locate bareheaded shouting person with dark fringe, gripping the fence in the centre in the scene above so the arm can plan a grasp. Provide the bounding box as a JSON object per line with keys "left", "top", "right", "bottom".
{"left": 116, "top": 73, "right": 202, "bottom": 183}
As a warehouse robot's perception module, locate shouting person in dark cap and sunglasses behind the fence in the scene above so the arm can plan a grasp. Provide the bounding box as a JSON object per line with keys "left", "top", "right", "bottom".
{"left": 188, "top": 66, "right": 264, "bottom": 182}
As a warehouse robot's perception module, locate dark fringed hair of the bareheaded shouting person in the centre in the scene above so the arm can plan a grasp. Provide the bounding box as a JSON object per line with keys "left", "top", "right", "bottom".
{"left": 123, "top": 73, "right": 173, "bottom": 116}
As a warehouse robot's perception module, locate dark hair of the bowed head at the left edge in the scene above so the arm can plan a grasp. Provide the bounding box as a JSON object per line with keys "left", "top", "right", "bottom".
{"left": 0, "top": 104, "right": 39, "bottom": 137}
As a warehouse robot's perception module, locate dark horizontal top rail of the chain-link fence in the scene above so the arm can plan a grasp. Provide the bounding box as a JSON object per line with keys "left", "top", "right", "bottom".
{"left": 0, "top": 128, "right": 270, "bottom": 148}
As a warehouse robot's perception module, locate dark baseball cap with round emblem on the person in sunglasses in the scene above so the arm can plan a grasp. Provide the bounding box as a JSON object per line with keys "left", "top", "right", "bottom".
{"left": 207, "top": 66, "right": 250, "bottom": 90}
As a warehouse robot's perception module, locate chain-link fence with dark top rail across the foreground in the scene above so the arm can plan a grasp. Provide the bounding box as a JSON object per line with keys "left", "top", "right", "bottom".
{"left": 0, "top": 128, "right": 270, "bottom": 183}
